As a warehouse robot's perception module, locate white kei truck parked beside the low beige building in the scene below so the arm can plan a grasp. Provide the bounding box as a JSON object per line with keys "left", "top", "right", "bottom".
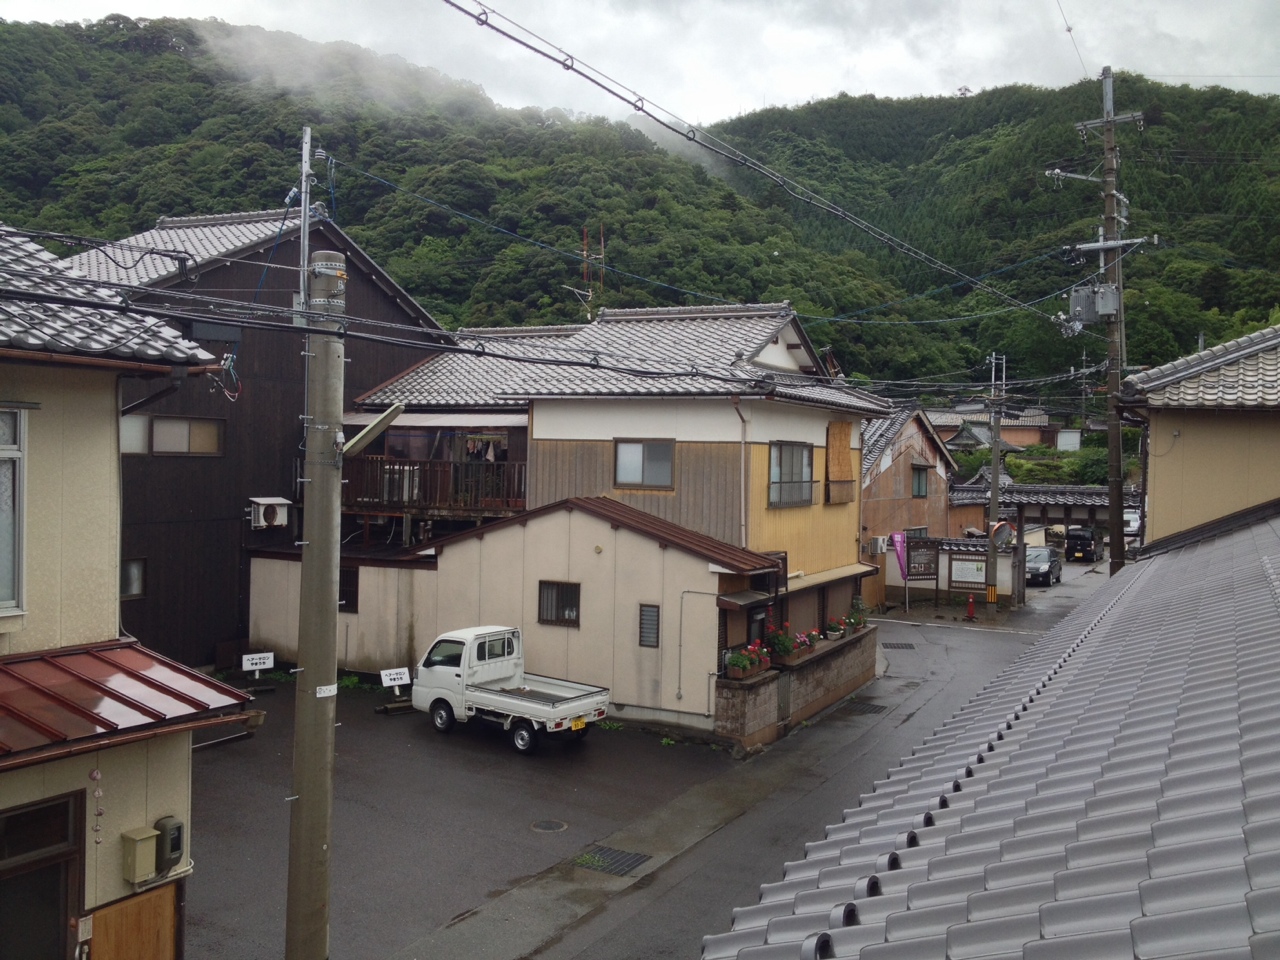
{"left": 413, "top": 626, "right": 609, "bottom": 754}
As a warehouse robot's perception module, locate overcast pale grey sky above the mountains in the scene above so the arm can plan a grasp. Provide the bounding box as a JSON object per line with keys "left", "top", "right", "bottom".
{"left": 10, "top": 0, "right": 1280, "bottom": 124}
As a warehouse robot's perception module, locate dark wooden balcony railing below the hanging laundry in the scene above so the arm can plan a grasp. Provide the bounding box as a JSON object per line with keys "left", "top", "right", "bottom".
{"left": 342, "top": 457, "right": 527, "bottom": 516}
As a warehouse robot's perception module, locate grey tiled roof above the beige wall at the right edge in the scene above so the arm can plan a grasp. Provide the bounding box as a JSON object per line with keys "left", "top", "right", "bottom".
{"left": 1120, "top": 325, "right": 1280, "bottom": 408}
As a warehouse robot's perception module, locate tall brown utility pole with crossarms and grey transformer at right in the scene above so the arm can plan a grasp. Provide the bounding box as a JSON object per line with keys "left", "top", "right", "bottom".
{"left": 1064, "top": 67, "right": 1158, "bottom": 575}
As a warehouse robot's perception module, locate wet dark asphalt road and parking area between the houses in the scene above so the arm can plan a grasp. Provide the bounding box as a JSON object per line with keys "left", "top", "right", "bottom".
{"left": 187, "top": 564, "right": 1106, "bottom": 960}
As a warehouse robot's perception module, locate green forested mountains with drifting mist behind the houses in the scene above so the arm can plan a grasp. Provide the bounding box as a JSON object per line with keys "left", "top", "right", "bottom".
{"left": 0, "top": 17, "right": 1280, "bottom": 408}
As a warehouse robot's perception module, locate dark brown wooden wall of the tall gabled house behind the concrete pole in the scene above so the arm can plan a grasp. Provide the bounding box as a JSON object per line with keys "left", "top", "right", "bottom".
{"left": 120, "top": 232, "right": 440, "bottom": 666}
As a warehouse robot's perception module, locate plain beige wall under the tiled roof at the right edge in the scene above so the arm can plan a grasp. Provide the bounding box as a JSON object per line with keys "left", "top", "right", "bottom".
{"left": 1147, "top": 410, "right": 1280, "bottom": 543}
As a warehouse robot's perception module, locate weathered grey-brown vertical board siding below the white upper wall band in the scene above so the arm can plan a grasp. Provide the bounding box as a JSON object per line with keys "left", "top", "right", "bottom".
{"left": 529, "top": 440, "right": 747, "bottom": 544}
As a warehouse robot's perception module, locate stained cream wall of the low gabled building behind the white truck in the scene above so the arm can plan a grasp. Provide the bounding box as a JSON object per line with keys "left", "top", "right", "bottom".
{"left": 250, "top": 511, "right": 719, "bottom": 726}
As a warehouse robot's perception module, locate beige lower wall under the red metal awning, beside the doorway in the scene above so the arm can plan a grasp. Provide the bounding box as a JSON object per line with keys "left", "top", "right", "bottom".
{"left": 0, "top": 733, "right": 192, "bottom": 910}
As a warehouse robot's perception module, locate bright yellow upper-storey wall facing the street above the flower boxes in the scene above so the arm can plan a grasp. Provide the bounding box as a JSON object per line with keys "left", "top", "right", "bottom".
{"left": 746, "top": 443, "right": 861, "bottom": 573}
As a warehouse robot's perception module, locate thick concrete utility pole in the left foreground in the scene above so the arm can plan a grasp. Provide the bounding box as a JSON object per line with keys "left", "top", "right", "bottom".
{"left": 284, "top": 128, "right": 347, "bottom": 960}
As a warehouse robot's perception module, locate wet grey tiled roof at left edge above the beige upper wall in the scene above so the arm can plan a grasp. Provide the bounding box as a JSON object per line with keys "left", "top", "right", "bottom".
{"left": 0, "top": 224, "right": 214, "bottom": 366}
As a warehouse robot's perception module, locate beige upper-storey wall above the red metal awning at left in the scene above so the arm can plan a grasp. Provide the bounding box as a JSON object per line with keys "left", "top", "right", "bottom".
{"left": 0, "top": 364, "right": 120, "bottom": 654}
